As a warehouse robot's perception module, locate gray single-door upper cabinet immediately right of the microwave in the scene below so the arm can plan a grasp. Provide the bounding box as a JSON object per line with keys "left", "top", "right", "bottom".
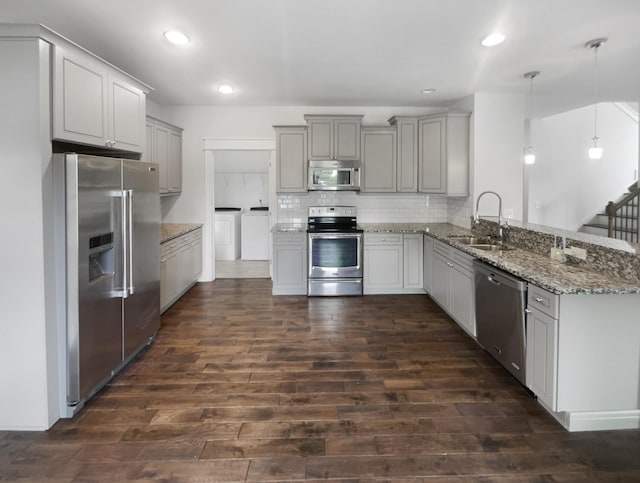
{"left": 361, "top": 127, "right": 396, "bottom": 193}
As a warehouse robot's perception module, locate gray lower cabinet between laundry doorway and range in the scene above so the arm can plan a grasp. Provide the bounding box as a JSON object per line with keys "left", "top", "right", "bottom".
{"left": 272, "top": 233, "right": 308, "bottom": 295}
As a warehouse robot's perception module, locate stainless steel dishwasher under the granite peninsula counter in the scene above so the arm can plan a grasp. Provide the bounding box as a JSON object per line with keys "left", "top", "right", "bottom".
{"left": 473, "top": 260, "right": 527, "bottom": 384}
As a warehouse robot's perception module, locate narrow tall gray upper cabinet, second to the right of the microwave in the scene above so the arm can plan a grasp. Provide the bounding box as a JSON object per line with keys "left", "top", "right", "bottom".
{"left": 389, "top": 116, "right": 418, "bottom": 193}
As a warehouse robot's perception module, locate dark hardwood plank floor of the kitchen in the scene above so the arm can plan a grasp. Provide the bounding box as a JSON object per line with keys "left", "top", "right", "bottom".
{"left": 0, "top": 279, "right": 640, "bottom": 482}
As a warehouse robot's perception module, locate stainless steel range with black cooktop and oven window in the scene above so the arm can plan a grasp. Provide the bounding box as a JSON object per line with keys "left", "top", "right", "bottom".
{"left": 307, "top": 206, "right": 362, "bottom": 296}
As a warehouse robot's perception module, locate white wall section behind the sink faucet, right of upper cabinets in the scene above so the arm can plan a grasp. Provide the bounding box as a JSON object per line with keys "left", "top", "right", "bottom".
{"left": 471, "top": 92, "right": 524, "bottom": 220}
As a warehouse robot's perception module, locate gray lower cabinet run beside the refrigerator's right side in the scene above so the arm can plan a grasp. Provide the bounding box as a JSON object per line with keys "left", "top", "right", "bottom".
{"left": 160, "top": 228, "right": 202, "bottom": 312}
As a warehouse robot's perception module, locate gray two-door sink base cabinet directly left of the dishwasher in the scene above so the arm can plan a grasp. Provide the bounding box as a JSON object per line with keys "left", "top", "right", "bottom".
{"left": 431, "top": 240, "right": 476, "bottom": 338}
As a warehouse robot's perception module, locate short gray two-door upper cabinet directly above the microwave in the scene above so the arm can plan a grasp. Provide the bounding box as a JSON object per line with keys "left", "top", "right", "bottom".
{"left": 304, "top": 115, "right": 362, "bottom": 160}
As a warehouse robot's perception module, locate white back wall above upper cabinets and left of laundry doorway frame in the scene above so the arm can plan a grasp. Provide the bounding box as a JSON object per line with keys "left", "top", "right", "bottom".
{"left": 159, "top": 106, "right": 442, "bottom": 223}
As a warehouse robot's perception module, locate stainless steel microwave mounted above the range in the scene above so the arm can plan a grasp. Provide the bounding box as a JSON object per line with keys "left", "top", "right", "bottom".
{"left": 307, "top": 159, "right": 360, "bottom": 191}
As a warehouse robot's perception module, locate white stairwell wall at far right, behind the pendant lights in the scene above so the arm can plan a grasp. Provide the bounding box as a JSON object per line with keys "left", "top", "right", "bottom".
{"left": 529, "top": 103, "right": 638, "bottom": 230}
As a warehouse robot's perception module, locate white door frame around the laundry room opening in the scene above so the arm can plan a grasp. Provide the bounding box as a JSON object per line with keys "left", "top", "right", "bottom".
{"left": 199, "top": 139, "right": 276, "bottom": 282}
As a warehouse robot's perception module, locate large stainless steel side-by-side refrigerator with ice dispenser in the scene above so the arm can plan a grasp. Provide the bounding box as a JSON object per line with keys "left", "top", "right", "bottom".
{"left": 54, "top": 153, "right": 160, "bottom": 417}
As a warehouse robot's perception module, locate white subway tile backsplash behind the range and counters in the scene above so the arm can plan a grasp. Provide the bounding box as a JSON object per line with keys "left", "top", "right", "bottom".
{"left": 277, "top": 191, "right": 471, "bottom": 228}
